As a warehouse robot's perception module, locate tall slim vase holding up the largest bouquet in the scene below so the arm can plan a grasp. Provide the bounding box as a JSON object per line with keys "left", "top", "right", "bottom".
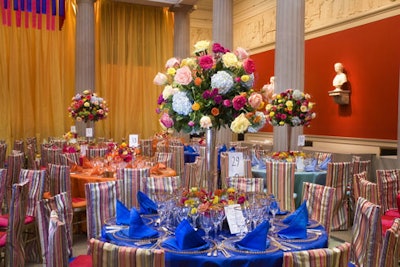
{"left": 205, "top": 128, "right": 217, "bottom": 192}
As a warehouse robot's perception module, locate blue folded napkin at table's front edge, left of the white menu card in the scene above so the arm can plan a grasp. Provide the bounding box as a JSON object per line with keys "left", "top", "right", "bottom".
{"left": 162, "top": 219, "right": 210, "bottom": 251}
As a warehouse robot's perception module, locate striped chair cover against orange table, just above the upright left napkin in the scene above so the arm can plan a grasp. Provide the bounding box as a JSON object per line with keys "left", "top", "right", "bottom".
{"left": 117, "top": 168, "right": 150, "bottom": 209}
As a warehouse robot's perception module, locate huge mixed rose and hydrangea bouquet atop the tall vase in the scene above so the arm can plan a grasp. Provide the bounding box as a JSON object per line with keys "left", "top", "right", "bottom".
{"left": 154, "top": 41, "right": 266, "bottom": 134}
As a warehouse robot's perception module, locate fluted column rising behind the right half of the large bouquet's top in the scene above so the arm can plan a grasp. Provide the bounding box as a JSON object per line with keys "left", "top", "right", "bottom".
{"left": 212, "top": 0, "right": 233, "bottom": 147}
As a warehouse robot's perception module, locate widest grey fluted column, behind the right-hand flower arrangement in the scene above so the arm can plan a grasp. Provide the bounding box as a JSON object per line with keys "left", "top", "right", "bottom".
{"left": 274, "top": 0, "right": 305, "bottom": 151}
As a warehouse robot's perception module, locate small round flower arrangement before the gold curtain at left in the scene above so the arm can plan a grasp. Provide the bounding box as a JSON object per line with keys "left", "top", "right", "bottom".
{"left": 68, "top": 90, "right": 108, "bottom": 122}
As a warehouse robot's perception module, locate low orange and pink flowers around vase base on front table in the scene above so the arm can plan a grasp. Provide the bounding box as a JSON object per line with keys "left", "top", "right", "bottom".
{"left": 180, "top": 187, "right": 246, "bottom": 212}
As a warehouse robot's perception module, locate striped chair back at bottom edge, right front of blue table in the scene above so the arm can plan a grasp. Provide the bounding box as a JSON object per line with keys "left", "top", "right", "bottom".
{"left": 282, "top": 242, "right": 350, "bottom": 267}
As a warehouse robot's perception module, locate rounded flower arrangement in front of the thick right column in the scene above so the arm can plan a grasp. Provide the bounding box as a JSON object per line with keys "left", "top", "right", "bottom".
{"left": 265, "top": 89, "right": 316, "bottom": 126}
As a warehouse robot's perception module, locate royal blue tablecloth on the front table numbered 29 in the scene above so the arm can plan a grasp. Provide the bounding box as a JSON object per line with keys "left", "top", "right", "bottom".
{"left": 102, "top": 216, "right": 328, "bottom": 267}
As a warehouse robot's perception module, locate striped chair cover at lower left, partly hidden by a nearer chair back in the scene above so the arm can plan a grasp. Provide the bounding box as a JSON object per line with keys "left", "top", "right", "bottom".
{"left": 37, "top": 192, "right": 73, "bottom": 266}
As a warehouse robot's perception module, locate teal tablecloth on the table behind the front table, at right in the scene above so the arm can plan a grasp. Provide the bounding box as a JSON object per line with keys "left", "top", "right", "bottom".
{"left": 251, "top": 167, "right": 326, "bottom": 208}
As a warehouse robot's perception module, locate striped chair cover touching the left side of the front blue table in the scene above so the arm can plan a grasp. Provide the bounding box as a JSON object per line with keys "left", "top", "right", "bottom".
{"left": 85, "top": 181, "right": 118, "bottom": 245}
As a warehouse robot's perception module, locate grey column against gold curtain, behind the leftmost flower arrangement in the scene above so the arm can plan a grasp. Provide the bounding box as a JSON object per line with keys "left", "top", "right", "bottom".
{"left": 75, "top": 0, "right": 95, "bottom": 136}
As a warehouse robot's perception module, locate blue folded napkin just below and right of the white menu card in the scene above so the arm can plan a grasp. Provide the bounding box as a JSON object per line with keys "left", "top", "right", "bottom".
{"left": 235, "top": 221, "right": 270, "bottom": 251}
